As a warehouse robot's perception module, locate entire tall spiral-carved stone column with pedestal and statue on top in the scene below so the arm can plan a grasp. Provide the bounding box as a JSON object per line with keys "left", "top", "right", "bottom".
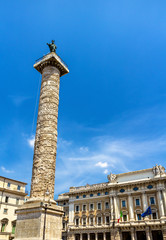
{"left": 15, "top": 41, "right": 69, "bottom": 240}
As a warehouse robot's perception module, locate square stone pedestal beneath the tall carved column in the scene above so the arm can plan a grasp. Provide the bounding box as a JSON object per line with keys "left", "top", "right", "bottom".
{"left": 15, "top": 201, "right": 63, "bottom": 240}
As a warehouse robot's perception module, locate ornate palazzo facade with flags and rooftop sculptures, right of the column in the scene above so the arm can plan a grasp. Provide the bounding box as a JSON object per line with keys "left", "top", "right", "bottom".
{"left": 57, "top": 165, "right": 166, "bottom": 240}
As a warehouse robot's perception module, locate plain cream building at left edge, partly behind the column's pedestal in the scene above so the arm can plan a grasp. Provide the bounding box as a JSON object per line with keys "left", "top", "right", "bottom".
{"left": 0, "top": 176, "right": 27, "bottom": 240}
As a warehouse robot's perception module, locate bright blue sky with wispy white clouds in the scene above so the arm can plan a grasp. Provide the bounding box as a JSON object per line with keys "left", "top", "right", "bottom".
{"left": 0, "top": 0, "right": 166, "bottom": 196}
